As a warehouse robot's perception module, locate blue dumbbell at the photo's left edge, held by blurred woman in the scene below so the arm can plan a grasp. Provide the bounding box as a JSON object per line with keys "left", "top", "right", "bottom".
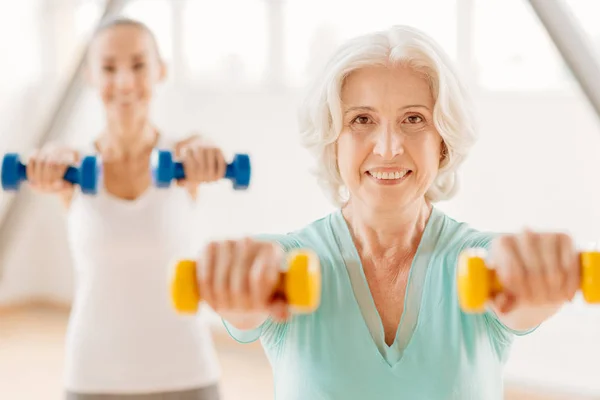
{"left": 2, "top": 153, "right": 100, "bottom": 194}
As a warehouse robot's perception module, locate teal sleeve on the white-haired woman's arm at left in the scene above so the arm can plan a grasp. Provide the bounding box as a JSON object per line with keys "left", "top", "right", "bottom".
{"left": 221, "top": 234, "right": 300, "bottom": 344}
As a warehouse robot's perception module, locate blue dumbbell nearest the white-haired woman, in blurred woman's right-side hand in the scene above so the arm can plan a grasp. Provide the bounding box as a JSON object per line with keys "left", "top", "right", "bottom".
{"left": 150, "top": 149, "right": 251, "bottom": 190}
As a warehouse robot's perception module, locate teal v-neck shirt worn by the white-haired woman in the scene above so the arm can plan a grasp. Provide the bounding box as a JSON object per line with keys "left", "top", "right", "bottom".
{"left": 225, "top": 207, "right": 525, "bottom": 400}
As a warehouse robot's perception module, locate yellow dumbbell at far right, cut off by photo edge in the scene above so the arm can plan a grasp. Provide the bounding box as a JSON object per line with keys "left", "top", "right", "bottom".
{"left": 456, "top": 249, "right": 600, "bottom": 313}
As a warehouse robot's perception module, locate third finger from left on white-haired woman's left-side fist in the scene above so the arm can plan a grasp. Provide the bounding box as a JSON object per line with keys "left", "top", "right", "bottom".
{"left": 229, "top": 239, "right": 253, "bottom": 311}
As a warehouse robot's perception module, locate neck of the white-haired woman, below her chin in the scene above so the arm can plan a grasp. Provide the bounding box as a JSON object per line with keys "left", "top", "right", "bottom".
{"left": 342, "top": 199, "right": 432, "bottom": 259}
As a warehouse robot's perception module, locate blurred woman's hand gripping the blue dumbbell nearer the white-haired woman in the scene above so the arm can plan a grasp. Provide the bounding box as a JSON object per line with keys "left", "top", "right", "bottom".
{"left": 175, "top": 135, "right": 226, "bottom": 188}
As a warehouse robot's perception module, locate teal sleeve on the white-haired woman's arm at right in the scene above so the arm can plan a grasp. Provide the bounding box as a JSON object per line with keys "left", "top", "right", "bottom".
{"left": 463, "top": 232, "right": 538, "bottom": 358}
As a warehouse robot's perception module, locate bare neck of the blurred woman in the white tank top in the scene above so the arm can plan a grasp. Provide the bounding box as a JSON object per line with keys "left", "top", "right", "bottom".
{"left": 97, "top": 121, "right": 158, "bottom": 160}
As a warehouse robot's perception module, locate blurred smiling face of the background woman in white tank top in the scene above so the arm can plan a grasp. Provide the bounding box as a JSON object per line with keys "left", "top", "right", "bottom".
{"left": 88, "top": 25, "right": 166, "bottom": 120}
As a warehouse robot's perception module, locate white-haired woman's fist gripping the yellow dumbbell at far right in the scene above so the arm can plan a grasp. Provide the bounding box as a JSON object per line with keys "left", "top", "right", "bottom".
{"left": 490, "top": 230, "right": 580, "bottom": 313}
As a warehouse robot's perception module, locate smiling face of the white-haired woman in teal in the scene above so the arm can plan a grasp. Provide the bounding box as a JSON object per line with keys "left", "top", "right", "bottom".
{"left": 337, "top": 66, "right": 442, "bottom": 211}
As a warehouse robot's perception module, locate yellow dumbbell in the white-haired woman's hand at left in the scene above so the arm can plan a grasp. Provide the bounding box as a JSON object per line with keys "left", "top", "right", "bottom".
{"left": 171, "top": 249, "right": 321, "bottom": 313}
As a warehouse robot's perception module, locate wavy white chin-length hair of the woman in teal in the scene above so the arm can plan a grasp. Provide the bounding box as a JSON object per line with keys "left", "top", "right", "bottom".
{"left": 299, "top": 26, "right": 477, "bottom": 206}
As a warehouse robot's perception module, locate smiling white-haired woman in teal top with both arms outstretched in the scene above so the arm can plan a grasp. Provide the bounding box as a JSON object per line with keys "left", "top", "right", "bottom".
{"left": 198, "top": 27, "right": 578, "bottom": 400}
